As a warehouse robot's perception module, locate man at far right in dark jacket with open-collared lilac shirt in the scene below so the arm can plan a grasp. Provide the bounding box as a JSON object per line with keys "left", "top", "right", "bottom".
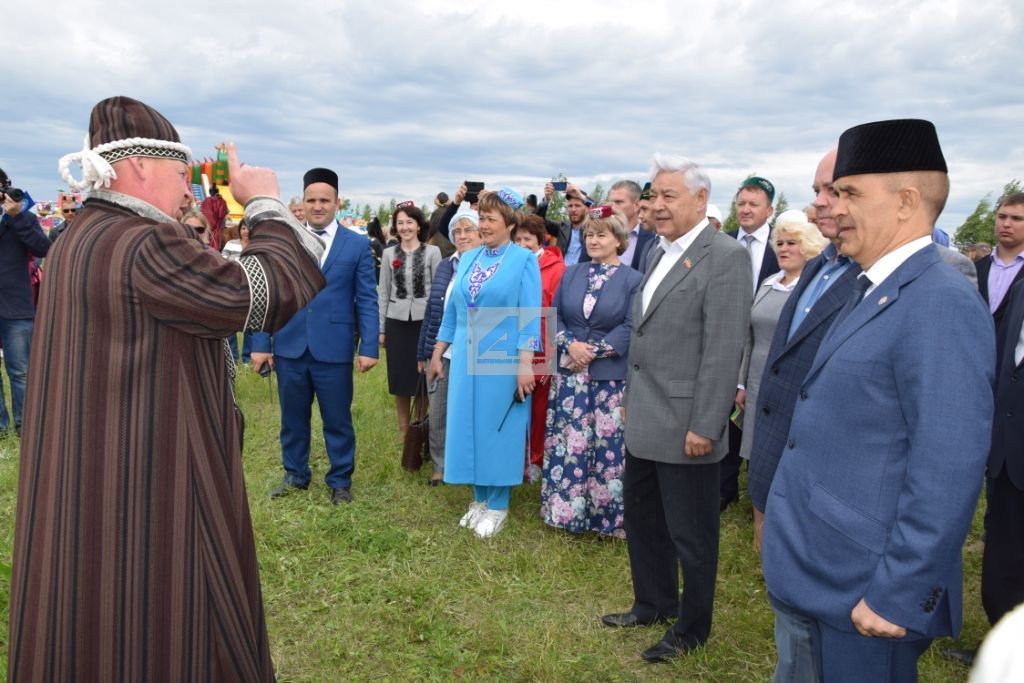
{"left": 975, "top": 193, "right": 1024, "bottom": 335}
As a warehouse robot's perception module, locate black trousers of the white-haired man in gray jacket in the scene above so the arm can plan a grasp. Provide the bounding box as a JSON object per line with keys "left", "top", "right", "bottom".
{"left": 623, "top": 452, "right": 719, "bottom": 645}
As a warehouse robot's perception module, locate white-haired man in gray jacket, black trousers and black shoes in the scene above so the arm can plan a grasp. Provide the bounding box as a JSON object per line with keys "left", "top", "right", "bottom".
{"left": 601, "top": 155, "right": 753, "bottom": 661}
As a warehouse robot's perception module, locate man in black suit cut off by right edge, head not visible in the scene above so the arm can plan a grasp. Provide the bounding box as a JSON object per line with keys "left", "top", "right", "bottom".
{"left": 981, "top": 278, "right": 1024, "bottom": 625}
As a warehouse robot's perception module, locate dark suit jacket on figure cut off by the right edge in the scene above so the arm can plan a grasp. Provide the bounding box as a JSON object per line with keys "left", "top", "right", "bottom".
{"left": 988, "top": 278, "right": 1024, "bottom": 490}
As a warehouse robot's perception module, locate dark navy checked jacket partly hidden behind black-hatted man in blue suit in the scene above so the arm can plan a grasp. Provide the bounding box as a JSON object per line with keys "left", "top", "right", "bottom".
{"left": 748, "top": 246, "right": 860, "bottom": 512}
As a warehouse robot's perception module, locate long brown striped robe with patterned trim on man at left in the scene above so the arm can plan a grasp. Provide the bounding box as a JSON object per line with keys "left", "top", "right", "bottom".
{"left": 8, "top": 193, "right": 324, "bottom": 682}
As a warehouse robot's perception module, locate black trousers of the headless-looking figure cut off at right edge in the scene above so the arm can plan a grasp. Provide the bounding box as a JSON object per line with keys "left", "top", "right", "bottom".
{"left": 981, "top": 467, "right": 1024, "bottom": 624}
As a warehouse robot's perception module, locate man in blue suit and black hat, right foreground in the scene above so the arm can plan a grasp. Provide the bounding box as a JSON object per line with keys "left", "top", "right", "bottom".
{"left": 764, "top": 120, "right": 995, "bottom": 681}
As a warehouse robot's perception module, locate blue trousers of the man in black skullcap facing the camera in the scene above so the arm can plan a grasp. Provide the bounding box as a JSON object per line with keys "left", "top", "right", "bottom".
{"left": 273, "top": 349, "right": 355, "bottom": 488}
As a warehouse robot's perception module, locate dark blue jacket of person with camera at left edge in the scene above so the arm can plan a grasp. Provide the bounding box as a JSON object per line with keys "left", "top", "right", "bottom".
{"left": 0, "top": 210, "right": 50, "bottom": 319}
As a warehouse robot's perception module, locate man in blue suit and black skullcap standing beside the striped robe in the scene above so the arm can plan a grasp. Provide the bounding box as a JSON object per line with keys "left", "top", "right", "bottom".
{"left": 252, "top": 168, "right": 379, "bottom": 505}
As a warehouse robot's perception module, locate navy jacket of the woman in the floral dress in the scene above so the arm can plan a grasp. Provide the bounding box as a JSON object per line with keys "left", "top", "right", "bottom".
{"left": 551, "top": 263, "right": 643, "bottom": 380}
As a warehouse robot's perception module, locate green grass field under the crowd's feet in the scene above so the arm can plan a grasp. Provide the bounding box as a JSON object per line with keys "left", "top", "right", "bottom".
{"left": 0, "top": 360, "right": 987, "bottom": 682}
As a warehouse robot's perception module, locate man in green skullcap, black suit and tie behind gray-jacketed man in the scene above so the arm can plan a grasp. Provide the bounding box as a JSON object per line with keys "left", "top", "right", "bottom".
{"left": 719, "top": 175, "right": 778, "bottom": 511}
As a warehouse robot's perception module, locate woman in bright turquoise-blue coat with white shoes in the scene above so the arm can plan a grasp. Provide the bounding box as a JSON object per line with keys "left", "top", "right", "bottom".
{"left": 428, "top": 189, "right": 541, "bottom": 538}
